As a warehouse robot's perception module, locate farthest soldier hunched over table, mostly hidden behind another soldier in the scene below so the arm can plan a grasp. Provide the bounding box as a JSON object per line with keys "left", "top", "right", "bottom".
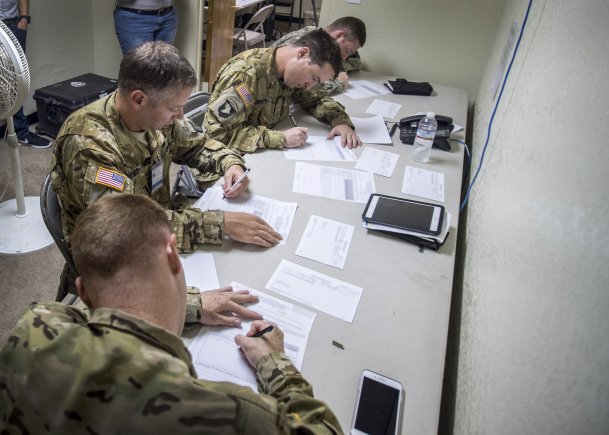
{"left": 271, "top": 17, "right": 366, "bottom": 94}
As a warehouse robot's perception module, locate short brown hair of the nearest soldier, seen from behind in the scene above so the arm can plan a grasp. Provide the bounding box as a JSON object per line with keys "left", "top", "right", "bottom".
{"left": 70, "top": 193, "right": 171, "bottom": 281}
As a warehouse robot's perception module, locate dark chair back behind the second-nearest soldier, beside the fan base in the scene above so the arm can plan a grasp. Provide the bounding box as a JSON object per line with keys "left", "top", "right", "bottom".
{"left": 40, "top": 174, "right": 78, "bottom": 305}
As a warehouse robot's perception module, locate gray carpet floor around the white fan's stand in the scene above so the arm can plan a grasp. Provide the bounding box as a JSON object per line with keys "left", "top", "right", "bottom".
{"left": 0, "top": 127, "right": 63, "bottom": 344}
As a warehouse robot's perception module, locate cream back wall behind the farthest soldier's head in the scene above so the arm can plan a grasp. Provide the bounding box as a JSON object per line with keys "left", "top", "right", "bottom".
{"left": 320, "top": 0, "right": 505, "bottom": 103}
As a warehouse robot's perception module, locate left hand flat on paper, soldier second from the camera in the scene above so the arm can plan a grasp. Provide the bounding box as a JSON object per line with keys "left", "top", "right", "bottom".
{"left": 224, "top": 211, "right": 283, "bottom": 248}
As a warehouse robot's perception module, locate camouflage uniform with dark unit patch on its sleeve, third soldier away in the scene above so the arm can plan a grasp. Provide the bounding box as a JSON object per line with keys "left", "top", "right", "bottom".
{"left": 204, "top": 48, "right": 353, "bottom": 153}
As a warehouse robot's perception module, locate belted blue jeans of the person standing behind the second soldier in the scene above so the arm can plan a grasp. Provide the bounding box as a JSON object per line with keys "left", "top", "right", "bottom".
{"left": 114, "top": 6, "right": 178, "bottom": 54}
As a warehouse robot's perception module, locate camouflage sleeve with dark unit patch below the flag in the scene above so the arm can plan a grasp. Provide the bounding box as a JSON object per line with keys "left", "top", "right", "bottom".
{"left": 203, "top": 60, "right": 284, "bottom": 153}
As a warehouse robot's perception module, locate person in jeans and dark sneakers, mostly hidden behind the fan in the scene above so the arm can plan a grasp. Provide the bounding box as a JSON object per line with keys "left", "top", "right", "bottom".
{"left": 0, "top": 0, "right": 53, "bottom": 148}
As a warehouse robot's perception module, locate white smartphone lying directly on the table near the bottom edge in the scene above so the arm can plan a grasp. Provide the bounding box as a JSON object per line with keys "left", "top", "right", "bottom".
{"left": 351, "top": 370, "right": 403, "bottom": 435}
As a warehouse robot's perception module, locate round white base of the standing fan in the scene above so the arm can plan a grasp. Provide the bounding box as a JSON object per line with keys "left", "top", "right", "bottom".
{"left": 0, "top": 196, "right": 53, "bottom": 254}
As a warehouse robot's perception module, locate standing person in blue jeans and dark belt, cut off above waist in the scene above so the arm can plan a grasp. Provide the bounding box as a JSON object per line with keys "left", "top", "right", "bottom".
{"left": 114, "top": 0, "right": 178, "bottom": 54}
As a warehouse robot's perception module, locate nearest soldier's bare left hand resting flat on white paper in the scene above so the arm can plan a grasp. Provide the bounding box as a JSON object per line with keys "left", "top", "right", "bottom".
{"left": 200, "top": 287, "right": 262, "bottom": 326}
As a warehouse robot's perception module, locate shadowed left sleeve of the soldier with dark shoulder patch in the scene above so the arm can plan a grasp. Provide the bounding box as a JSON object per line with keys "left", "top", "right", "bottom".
{"left": 294, "top": 85, "right": 354, "bottom": 128}
